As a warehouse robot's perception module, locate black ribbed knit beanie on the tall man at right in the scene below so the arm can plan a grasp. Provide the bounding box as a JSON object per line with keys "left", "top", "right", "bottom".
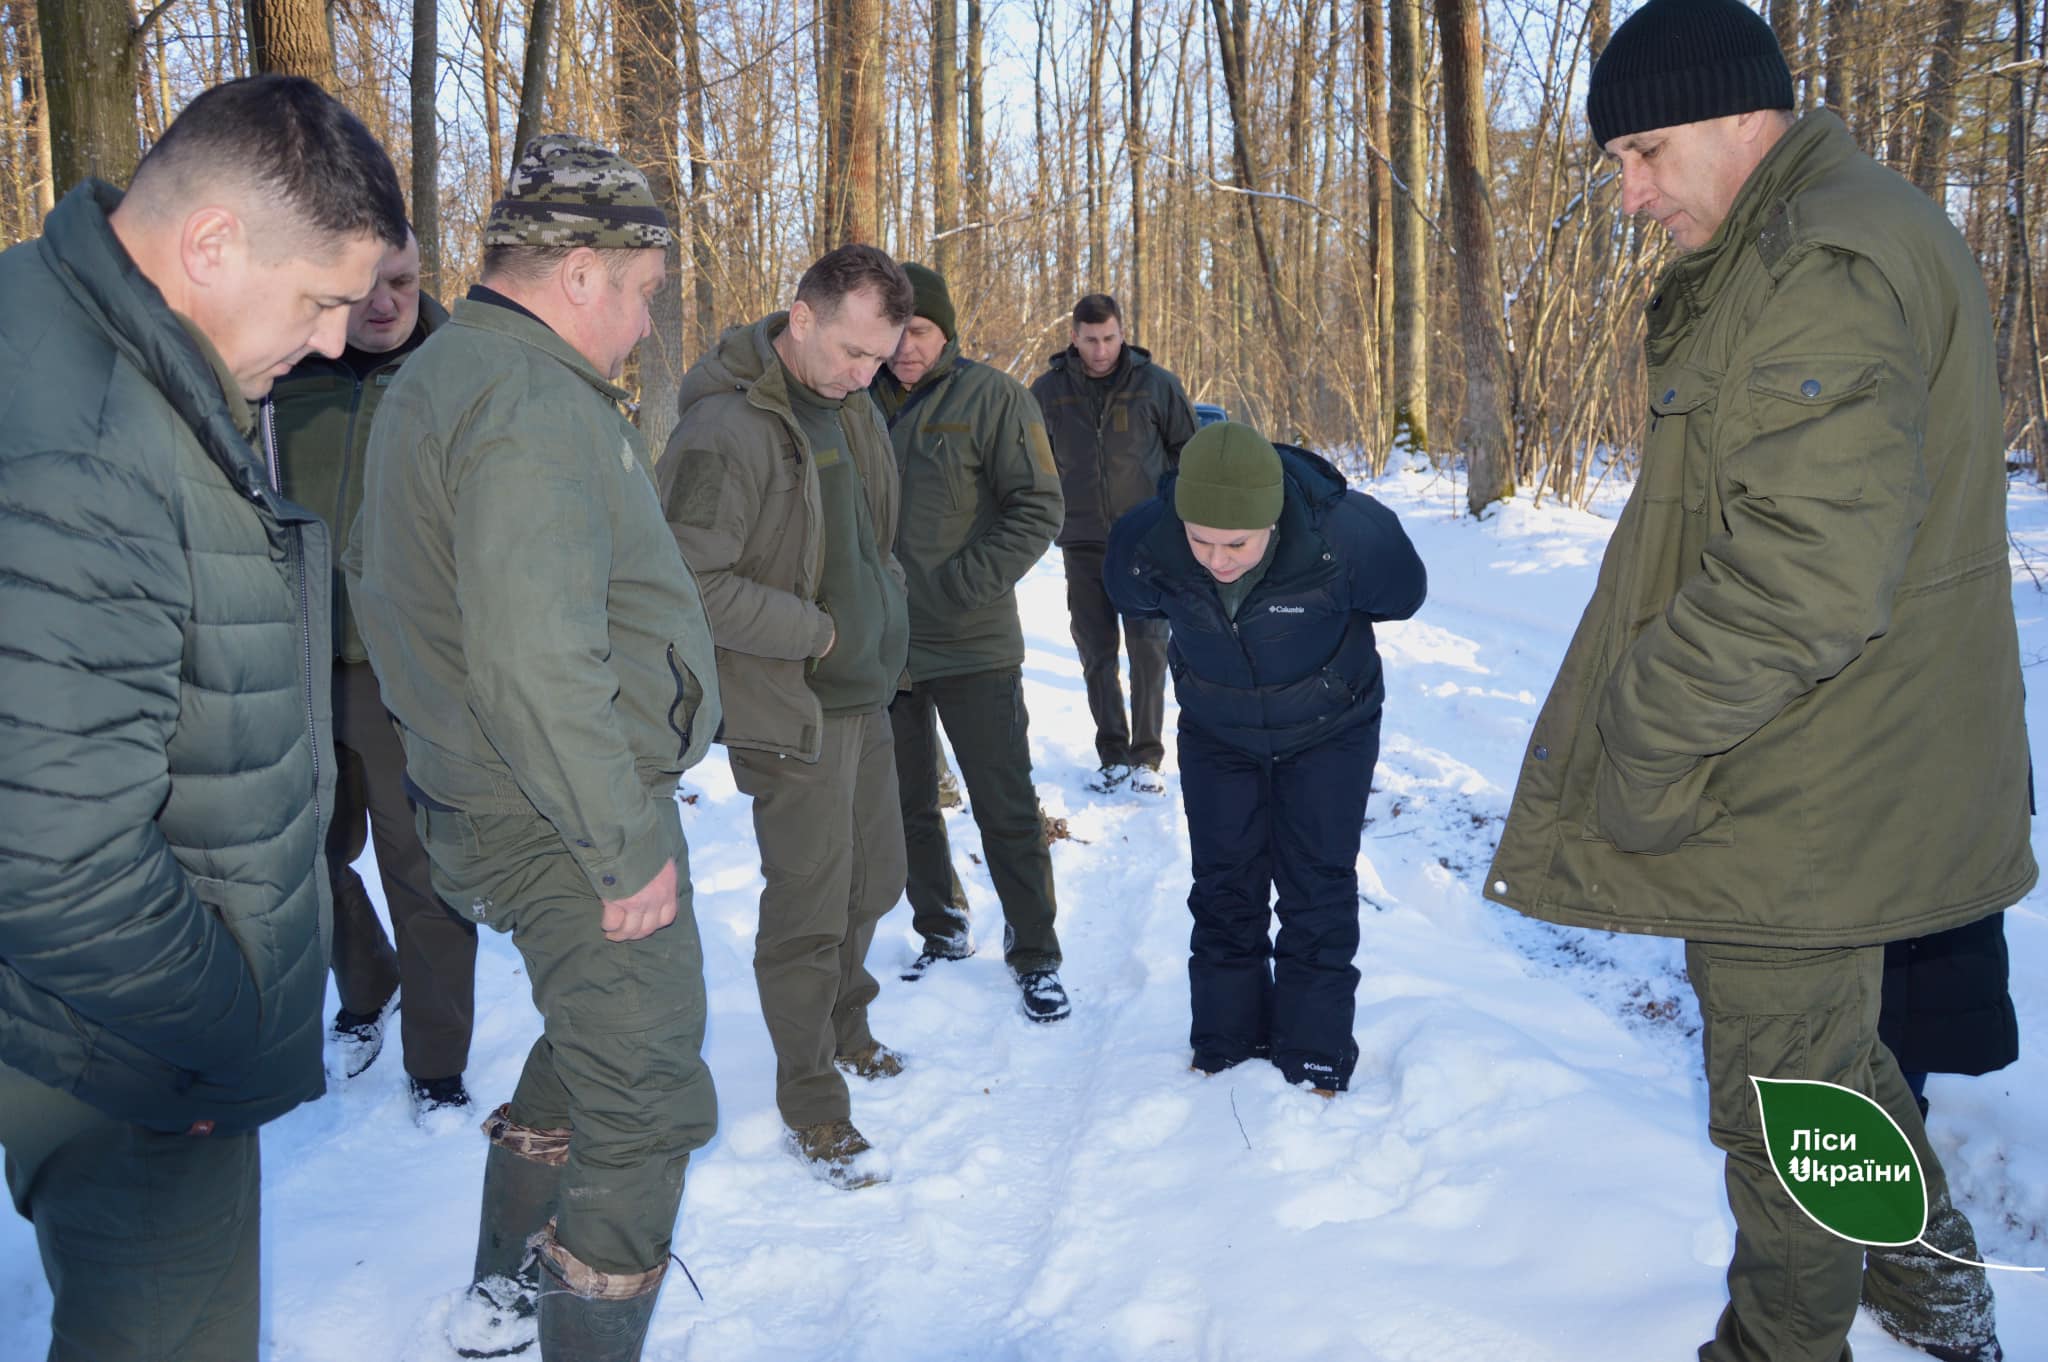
{"left": 1585, "top": 0, "right": 1794, "bottom": 145}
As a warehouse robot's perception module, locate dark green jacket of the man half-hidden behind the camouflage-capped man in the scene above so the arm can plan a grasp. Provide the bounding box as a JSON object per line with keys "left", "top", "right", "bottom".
{"left": 264, "top": 295, "right": 449, "bottom": 662}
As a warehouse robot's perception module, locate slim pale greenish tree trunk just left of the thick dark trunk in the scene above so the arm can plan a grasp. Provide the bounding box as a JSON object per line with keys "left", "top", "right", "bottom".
{"left": 1386, "top": 0, "right": 1430, "bottom": 455}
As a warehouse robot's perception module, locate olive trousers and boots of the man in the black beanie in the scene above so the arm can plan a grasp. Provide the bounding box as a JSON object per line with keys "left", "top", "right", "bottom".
{"left": 1686, "top": 942, "right": 1993, "bottom": 1362}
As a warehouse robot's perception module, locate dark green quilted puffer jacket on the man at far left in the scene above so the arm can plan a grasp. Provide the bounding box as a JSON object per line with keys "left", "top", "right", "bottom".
{"left": 0, "top": 180, "right": 334, "bottom": 1133}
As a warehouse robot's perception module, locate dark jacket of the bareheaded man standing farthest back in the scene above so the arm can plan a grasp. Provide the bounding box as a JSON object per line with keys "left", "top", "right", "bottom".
{"left": 1030, "top": 344, "right": 1194, "bottom": 549}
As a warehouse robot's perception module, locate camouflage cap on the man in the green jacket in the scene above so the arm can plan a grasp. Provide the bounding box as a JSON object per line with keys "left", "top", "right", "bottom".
{"left": 483, "top": 133, "right": 676, "bottom": 250}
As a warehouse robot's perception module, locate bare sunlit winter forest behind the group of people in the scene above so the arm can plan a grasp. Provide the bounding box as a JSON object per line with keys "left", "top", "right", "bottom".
{"left": 0, "top": 0, "right": 2048, "bottom": 514}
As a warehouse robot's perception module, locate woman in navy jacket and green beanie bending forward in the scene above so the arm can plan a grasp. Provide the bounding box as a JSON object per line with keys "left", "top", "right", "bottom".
{"left": 1102, "top": 422, "right": 1425, "bottom": 1096}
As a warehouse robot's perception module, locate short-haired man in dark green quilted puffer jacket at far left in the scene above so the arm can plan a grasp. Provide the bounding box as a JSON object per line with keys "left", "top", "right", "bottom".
{"left": 0, "top": 76, "right": 406, "bottom": 1362}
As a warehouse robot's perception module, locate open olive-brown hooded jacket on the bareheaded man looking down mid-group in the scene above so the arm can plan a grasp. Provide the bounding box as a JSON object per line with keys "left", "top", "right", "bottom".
{"left": 655, "top": 311, "right": 905, "bottom": 762}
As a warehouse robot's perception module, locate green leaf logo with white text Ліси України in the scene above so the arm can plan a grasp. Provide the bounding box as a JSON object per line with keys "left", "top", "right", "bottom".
{"left": 1749, "top": 1075, "right": 1927, "bottom": 1247}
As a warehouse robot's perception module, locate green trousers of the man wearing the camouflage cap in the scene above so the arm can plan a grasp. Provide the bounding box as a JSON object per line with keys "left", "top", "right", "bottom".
{"left": 418, "top": 801, "right": 719, "bottom": 1272}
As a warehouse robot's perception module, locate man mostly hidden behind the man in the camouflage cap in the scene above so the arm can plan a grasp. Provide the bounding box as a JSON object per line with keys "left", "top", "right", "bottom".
{"left": 264, "top": 231, "right": 477, "bottom": 1118}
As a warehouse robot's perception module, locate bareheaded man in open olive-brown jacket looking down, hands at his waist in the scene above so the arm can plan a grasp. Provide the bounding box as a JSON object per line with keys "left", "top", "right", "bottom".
{"left": 657, "top": 246, "right": 911, "bottom": 1188}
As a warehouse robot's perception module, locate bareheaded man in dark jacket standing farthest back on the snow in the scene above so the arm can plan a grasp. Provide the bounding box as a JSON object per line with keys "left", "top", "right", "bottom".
{"left": 1030, "top": 293, "right": 1194, "bottom": 795}
